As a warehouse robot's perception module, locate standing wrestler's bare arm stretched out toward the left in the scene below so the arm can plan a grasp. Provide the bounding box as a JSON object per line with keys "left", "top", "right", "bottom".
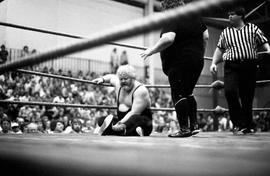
{"left": 140, "top": 32, "right": 176, "bottom": 59}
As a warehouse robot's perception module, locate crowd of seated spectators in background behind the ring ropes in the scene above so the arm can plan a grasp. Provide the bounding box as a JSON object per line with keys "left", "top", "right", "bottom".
{"left": 0, "top": 45, "right": 270, "bottom": 134}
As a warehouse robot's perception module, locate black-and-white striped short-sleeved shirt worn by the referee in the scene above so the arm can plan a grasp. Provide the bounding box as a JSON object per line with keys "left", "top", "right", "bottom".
{"left": 217, "top": 23, "right": 268, "bottom": 61}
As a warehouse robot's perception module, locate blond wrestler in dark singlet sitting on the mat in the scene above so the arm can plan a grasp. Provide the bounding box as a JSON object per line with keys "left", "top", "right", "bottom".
{"left": 93, "top": 65, "right": 152, "bottom": 136}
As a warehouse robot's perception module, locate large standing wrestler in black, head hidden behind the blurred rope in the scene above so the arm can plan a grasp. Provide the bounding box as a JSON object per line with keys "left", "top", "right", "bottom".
{"left": 141, "top": 0, "right": 208, "bottom": 137}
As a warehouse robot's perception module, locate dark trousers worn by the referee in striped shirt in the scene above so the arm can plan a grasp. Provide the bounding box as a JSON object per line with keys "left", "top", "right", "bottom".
{"left": 224, "top": 61, "right": 257, "bottom": 128}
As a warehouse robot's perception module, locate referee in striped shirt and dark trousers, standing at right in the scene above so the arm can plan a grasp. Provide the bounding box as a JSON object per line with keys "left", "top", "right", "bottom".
{"left": 210, "top": 7, "right": 270, "bottom": 134}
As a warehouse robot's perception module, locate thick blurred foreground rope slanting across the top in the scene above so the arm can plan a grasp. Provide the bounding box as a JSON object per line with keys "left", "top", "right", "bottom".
{"left": 0, "top": 0, "right": 244, "bottom": 74}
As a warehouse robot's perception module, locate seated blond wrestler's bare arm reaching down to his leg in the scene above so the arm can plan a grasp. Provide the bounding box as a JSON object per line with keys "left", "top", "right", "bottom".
{"left": 120, "top": 86, "right": 150, "bottom": 123}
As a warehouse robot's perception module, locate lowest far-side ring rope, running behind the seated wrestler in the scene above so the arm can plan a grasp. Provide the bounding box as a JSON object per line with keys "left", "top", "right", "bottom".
{"left": 0, "top": 100, "right": 270, "bottom": 113}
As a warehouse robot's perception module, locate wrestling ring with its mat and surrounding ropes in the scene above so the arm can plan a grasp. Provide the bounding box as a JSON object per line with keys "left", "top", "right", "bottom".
{"left": 0, "top": 0, "right": 270, "bottom": 176}
